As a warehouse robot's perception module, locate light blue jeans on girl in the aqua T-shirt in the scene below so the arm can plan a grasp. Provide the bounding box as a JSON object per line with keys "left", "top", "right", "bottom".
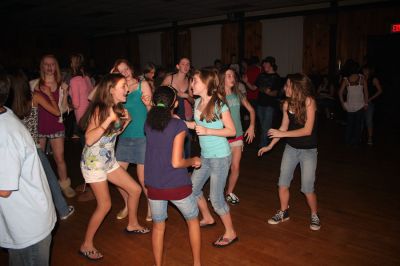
{"left": 192, "top": 155, "right": 232, "bottom": 216}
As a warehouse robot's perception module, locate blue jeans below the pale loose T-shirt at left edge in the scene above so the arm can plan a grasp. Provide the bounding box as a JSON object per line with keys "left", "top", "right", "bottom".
{"left": 8, "top": 234, "right": 51, "bottom": 266}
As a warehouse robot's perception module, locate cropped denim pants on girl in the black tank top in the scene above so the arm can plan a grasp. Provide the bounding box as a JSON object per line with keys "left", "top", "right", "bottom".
{"left": 278, "top": 144, "right": 318, "bottom": 193}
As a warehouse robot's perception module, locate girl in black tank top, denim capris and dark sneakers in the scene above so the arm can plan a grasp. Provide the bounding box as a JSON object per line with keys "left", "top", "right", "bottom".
{"left": 258, "top": 73, "right": 321, "bottom": 230}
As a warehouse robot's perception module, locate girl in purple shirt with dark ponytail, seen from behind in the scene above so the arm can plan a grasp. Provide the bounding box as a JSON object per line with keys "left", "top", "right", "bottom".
{"left": 144, "top": 86, "right": 201, "bottom": 265}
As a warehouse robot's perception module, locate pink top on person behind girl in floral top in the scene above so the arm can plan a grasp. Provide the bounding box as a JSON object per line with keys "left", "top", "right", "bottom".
{"left": 69, "top": 76, "right": 93, "bottom": 123}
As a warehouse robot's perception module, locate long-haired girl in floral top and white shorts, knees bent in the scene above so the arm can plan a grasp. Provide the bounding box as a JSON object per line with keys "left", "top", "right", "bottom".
{"left": 80, "top": 74, "right": 150, "bottom": 260}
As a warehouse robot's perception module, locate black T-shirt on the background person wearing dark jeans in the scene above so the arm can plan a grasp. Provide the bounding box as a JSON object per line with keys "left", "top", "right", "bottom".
{"left": 255, "top": 72, "right": 281, "bottom": 107}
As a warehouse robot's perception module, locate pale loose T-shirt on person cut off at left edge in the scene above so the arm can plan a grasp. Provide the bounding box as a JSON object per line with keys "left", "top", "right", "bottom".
{"left": 0, "top": 109, "right": 56, "bottom": 249}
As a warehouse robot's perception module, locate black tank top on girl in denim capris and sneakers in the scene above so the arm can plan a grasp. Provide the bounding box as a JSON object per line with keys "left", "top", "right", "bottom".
{"left": 286, "top": 110, "right": 317, "bottom": 149}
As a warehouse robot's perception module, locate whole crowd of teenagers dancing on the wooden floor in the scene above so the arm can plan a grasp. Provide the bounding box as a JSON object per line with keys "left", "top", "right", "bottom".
{"left": 0, "top": 54, "right": 382, "bottom": 265}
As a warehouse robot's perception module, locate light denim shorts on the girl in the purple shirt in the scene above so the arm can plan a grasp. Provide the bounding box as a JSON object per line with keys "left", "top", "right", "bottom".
{"left": 149, "top": 193, "right": 199, "bottom": 222}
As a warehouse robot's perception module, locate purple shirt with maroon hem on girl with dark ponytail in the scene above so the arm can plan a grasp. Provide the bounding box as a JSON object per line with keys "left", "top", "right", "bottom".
{"left": 144, "top": 118, "right": 192, "bottom": 200}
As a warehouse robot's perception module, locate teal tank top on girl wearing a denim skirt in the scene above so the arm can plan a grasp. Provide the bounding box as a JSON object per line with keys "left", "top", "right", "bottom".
{"left": 120, "top": 81, "right": 147, "bottom": 138}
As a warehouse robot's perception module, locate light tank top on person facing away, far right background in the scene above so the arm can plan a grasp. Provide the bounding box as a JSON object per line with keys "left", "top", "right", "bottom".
{"left": 344, "top": 75, "right": 365, "bottom": 113}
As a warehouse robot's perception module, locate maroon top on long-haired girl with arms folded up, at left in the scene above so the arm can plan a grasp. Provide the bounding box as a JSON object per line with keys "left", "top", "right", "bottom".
{"left": 37, "top": 89, "right": 64, "bottom": 135}
